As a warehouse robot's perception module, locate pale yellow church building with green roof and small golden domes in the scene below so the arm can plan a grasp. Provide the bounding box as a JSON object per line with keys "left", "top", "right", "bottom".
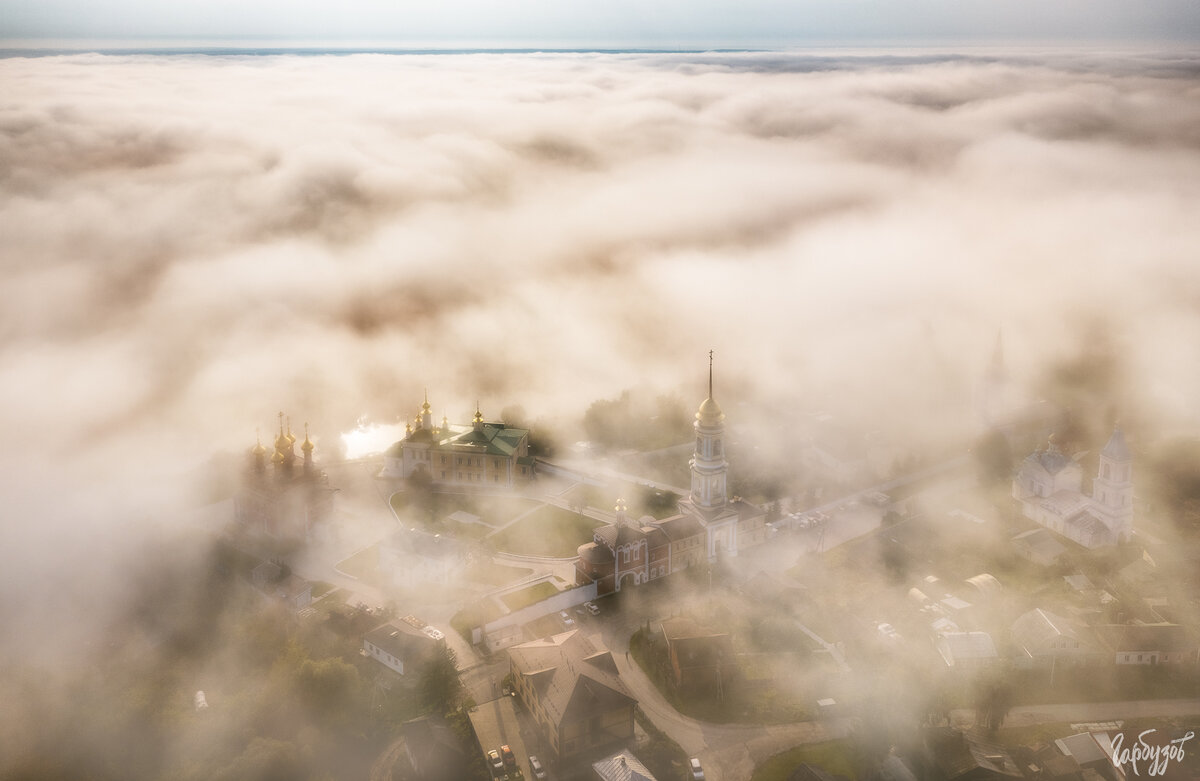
{"left": 382, "top": 397, "right": 533, "bottom": 488}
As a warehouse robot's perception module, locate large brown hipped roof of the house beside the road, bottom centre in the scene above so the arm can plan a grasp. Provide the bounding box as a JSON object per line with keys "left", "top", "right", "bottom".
{"left": 509, "top": 630, "right": 637, "bottom": 725}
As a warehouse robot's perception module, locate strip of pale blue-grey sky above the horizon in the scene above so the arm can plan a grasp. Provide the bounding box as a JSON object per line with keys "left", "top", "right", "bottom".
{"left": 7, "top": 0, "right": 1200, "bottom": 48}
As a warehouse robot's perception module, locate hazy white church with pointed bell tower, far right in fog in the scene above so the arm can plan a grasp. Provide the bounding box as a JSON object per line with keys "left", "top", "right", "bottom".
{"left": 1013, "top": 427, "right": 1133, "bottom": 548}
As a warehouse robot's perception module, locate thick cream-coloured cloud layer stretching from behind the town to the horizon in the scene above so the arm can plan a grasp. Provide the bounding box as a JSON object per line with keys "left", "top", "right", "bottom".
{"left": 0, "top": 53, "right": 1200, "bottom": 662}
